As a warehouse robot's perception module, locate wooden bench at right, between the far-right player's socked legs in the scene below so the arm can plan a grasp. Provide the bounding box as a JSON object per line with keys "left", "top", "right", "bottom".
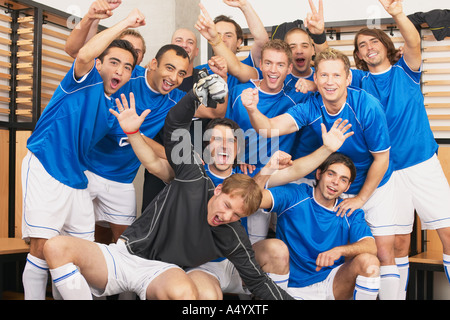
{"left": 408, "top": 251, "right": 444, "bottom": 300}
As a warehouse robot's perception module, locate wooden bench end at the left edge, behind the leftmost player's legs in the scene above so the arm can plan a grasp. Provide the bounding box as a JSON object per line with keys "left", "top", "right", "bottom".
{"left": 0, "top": 238, "right": 30, "bottom": 299}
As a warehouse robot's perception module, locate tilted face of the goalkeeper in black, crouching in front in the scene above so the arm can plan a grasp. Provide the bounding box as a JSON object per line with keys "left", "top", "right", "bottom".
{"left": 207, "top": 184, "right": 247, "bottom": 227}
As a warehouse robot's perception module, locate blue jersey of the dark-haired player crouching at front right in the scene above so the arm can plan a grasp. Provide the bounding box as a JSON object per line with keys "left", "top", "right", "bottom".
{"left": 269, "top": 183, "right": 372, "bottom": 287}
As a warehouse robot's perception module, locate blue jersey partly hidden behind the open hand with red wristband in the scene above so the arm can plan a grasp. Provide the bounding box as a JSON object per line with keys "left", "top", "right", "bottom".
{"left": 84, "top": 67, "right": 186, "bottom": 183}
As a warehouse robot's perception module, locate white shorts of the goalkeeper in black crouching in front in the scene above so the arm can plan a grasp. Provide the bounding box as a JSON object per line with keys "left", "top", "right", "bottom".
{"left": 91, "top": 239, "right": 181, "bottom": 300}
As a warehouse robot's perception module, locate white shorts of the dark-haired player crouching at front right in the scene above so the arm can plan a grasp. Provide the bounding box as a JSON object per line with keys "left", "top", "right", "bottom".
{"left": 287, "top": 265, "right": 342, "bottom": 300}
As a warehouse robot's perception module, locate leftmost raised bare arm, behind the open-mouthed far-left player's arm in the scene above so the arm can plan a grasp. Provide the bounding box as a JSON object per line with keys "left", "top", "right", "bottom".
{"left": 64, "top": 0, "right": 122, "bottom": 59}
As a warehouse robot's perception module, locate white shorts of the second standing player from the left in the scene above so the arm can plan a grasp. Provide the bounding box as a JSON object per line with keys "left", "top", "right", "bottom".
{"left": 84, "top": 171, "right": 136, "bottom": 227}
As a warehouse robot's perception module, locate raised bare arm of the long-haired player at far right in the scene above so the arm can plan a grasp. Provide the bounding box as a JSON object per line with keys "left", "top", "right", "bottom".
{"left": 379, "top": 0, "right": 422, "bottom": 71}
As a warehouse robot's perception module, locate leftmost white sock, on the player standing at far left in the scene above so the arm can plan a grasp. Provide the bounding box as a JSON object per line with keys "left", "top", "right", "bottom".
{"left": 22, "top": 254, "right": 48, "bottom": 300}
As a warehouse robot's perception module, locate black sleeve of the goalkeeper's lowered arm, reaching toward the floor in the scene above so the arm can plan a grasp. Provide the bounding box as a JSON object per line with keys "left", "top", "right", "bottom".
{"left": 215, "top": 221, "right": 293, "bottom": 300}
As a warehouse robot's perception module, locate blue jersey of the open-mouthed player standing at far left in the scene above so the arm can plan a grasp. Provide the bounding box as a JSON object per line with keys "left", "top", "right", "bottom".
{"left": 27, "top": 62, "right": 115, "bottom": 189}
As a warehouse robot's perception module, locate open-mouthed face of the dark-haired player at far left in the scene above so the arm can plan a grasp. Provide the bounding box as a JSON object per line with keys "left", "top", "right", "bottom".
{"left": 95, "top": 47, "right": 134, "bottom": 96}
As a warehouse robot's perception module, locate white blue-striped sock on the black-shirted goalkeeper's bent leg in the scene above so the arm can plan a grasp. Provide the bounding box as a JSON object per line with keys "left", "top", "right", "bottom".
{"left": 50, "top": 263, "right": 92, "bottom": 300}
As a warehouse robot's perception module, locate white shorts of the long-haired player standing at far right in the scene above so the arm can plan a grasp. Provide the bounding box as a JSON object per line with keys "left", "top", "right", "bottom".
{"left": 392, "top": 155, "right": 450, "bottom": 234}
